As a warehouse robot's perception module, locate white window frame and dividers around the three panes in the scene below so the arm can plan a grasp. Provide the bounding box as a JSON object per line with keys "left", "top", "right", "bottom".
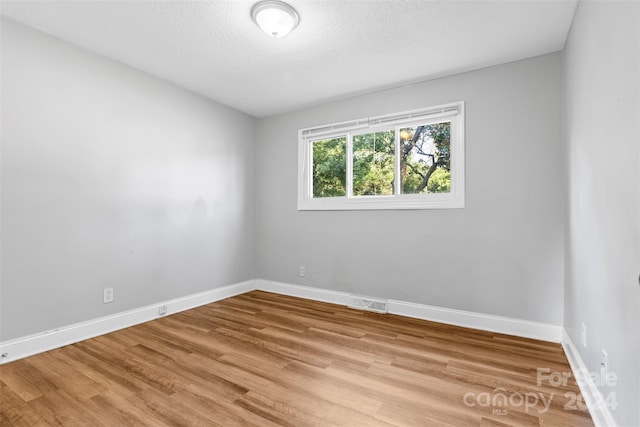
{"left": 298, "top": 101, "right": 465, "bottom": 210}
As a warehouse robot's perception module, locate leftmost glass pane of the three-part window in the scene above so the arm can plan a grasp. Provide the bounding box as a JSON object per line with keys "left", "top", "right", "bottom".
{"left": 312, "top": 137, "right": 347, "bottom": 197}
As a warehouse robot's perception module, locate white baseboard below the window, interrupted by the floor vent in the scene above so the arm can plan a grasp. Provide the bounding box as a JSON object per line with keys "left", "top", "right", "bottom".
{"left": 256, "top": 279, "right": 562, "bottom": 343}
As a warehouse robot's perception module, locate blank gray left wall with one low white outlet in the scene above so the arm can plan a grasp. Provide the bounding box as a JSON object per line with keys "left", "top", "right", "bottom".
{"left": 0, "top": 19, "right": 255, "bottom": 340}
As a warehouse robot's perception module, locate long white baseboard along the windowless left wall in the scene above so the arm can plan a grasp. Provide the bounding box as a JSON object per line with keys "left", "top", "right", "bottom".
{"left": 0, "top": 280, "right": 255, "bottom": 363}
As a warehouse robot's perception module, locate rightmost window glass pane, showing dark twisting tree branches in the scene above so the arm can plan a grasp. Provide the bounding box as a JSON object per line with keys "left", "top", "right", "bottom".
{"left": 400, "top": 122, "right": 451, "bottom": 194}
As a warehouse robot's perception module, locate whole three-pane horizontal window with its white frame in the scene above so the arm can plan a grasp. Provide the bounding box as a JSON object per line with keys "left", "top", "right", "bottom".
{"left": 298, "top": 102, "right": 464, "bottom": 210}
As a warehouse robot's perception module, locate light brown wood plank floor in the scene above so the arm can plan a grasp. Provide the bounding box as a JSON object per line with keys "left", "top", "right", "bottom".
{"left": 0, "top": 291, "right": 593, "bottom": 427}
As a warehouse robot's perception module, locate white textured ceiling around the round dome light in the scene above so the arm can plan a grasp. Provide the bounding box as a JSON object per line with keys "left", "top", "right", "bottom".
{"left": 1, "top": 0, "right": 577, "bottom": 117}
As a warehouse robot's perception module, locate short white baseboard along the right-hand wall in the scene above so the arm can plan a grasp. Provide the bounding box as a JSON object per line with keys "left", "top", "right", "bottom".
{"left": 562, "top": 328, "right": 616, "bottom": 427}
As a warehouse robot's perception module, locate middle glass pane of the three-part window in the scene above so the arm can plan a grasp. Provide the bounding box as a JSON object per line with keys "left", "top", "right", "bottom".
{"left": 353, "top": 130, "right": 395, "bottom": 196}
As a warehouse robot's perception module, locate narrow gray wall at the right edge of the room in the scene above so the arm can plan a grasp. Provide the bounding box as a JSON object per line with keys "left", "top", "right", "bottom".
{"left": 564, "top": 1, "right": 640, "bottom": 426}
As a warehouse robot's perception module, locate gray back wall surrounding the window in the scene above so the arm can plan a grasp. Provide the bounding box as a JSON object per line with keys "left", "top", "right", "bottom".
{"left": 256, "top": 54, "right": 564, "bottom": 325}
